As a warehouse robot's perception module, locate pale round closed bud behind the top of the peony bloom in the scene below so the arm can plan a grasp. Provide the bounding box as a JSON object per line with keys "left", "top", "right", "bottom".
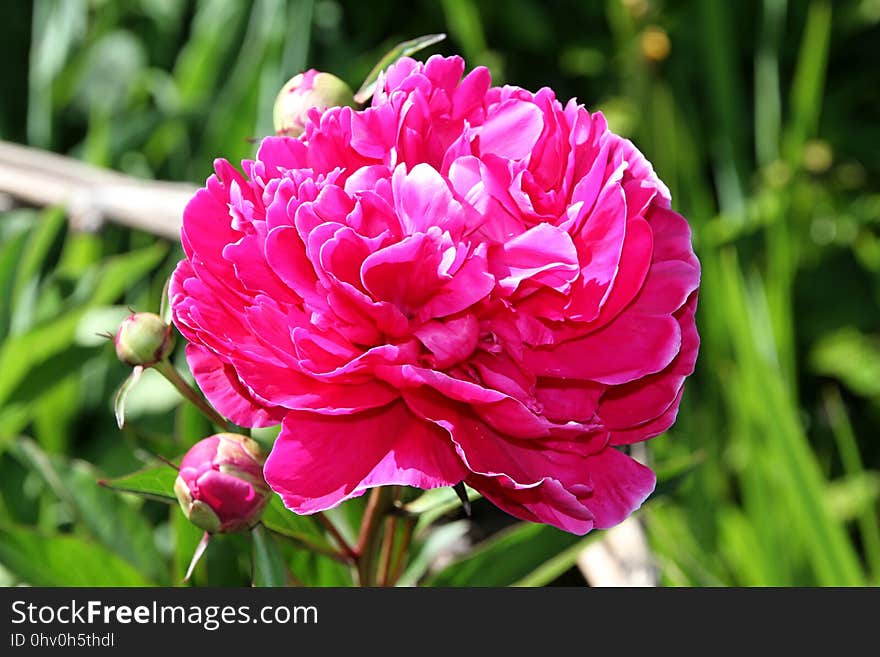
{"left": 272, "top": 69, "right": 354, "bottom": 137}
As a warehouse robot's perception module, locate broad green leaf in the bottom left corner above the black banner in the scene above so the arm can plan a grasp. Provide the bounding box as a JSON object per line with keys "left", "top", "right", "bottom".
{"left": 0, "top": 525, "right": 155, "bottom": 586}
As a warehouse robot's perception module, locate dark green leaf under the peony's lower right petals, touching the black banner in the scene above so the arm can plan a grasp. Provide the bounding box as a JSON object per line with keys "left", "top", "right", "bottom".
{"left": 428, "top": 523, "right": 583, "bottom": 586}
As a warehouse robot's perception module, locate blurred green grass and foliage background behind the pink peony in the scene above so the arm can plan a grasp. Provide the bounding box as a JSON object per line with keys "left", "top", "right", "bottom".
{"left": 0, "top": 0, "right": 880, "bottom": 586}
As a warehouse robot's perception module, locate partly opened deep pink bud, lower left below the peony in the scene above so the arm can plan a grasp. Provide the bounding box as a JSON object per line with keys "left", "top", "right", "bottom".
{"left": 174, "top": 433, "right": 272, "bottom": 533}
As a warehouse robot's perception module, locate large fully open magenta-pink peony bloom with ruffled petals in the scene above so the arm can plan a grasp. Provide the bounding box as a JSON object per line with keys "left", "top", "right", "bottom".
{"left": 171, "top": 57, "right": 700, "bottom": 534}
